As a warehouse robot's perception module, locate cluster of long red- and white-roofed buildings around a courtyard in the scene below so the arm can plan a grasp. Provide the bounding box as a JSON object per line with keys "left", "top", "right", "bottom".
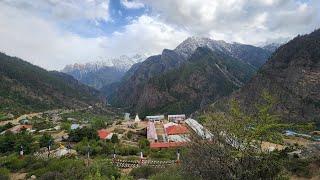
{"left": 146, "top": 114, "right": 212, "bottom": 149}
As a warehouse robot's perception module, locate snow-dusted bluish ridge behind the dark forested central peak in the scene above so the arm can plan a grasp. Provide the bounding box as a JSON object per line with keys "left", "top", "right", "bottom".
{"left": 102, "top": 37, "right": 271, "bottom": 114}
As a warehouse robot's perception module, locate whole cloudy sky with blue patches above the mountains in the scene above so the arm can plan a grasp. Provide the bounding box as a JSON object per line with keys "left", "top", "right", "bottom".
{"left": 0, "top": 0, "right": 320, "bottom": 70}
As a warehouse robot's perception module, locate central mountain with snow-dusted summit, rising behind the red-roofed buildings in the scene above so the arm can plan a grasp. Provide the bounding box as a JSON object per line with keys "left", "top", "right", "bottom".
{"left": 102, "top": 37, "right": 271, "bottom": 114}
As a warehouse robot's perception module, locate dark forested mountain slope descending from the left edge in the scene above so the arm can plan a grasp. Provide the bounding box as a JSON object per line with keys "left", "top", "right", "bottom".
{"left": 0, "top": 53, "right": 106, "bottom": 114}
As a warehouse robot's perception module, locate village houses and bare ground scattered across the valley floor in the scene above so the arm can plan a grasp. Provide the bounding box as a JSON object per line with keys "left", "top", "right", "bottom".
{"left": 0, "top": 106, "right": 320, "bottom": 176}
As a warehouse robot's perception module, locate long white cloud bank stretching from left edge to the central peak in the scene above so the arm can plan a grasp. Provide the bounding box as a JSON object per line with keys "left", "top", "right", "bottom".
{"left": 0, "top": 3, "right": 189, "bottom": 70}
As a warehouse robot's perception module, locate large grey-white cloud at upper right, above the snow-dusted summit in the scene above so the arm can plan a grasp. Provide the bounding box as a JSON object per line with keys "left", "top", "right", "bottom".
{"left": 143, "top": 0, "right": 320, "bottom": 44}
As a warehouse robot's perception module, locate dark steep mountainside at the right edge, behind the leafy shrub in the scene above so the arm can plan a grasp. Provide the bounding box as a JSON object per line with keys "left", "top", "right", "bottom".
{"left": 220, "top": 30, "right": 320, "bottom": 122}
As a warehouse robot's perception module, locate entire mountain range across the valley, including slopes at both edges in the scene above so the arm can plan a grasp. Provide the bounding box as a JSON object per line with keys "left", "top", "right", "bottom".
{"left": 0, "top": 30, "right": 320, "bottom": 122}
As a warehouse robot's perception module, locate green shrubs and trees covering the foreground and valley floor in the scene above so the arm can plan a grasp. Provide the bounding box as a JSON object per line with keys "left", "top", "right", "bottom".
{"left": 0, "top": 92, "right": 320, "bottom": 180}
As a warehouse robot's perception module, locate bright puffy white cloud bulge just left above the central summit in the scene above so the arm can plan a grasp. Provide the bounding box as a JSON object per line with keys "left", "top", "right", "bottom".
{"left": 104, "top": 15, "right": 190, "bottom": 57}
